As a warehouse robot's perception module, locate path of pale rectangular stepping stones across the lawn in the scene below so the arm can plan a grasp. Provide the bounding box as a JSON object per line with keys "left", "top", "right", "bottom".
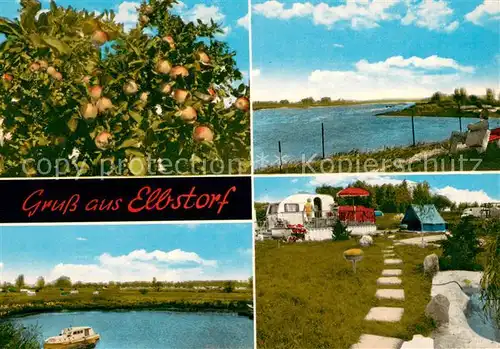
{"left": 351, "top": 243, "right": 405, "bottom": 349}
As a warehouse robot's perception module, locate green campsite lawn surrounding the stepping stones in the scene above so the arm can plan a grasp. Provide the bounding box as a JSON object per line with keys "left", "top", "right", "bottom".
{"left": 256, "top": 238, "right": 439, "bottom": 349}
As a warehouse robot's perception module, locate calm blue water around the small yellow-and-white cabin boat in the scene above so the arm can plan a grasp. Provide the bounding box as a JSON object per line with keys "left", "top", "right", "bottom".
{"left": 16, "top": 311, "right": 253, "bottom": 349}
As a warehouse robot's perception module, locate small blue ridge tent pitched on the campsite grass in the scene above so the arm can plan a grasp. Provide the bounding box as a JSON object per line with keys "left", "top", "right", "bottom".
{"left": 401, "top": 205, "right": 446, "bottom": 232}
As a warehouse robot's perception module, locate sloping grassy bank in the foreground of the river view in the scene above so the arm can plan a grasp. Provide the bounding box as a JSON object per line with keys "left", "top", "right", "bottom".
{"left": 255, "top": 141, "right": 500, "bottom": 174}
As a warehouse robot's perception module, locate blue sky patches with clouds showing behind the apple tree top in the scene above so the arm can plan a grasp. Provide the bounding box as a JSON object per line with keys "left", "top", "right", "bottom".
{"left": 0, "top": 0, "right": 250, "bottom": 74}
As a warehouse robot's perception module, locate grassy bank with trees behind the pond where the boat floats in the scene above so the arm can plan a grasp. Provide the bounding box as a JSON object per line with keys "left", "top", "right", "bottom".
{"left": 0, "top": 288, "right": 252, "bottom": 317}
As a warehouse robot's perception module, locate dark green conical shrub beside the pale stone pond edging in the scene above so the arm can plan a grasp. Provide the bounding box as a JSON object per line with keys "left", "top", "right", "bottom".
{"left": 439, "top": 217, "right": 480, "bottom": 270}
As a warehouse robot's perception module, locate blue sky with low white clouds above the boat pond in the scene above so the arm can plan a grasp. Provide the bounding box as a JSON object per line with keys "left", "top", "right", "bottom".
{"left": 0, "top": 223, "right": 252, "bottom": 283}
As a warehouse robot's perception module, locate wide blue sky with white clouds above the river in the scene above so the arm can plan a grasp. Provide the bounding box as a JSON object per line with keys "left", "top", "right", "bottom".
{"left": 252, "top": 0, "right": 500, "bottom": 100}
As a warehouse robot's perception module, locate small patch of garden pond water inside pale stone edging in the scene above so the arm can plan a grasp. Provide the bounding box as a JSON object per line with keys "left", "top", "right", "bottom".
{"left": 466, "top": 293, "right": 500, "bottom": 342}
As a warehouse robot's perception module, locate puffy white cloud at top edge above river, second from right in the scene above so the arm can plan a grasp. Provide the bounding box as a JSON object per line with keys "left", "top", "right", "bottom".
{"left": 401, "top": 0, "right": 459, "bottom": 33}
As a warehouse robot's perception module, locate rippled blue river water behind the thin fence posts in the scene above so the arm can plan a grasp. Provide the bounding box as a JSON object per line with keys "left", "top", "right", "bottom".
{"left": 253, "top": 104, "right": 500, "bottom": 168}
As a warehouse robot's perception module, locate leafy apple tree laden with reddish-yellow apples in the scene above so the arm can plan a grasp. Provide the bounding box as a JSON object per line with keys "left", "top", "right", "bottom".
{"left": 0, "top": 0, "right": 250, "bottom": 177}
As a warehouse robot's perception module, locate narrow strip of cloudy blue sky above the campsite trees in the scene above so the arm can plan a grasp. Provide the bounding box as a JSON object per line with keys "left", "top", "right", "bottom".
{"left": 254, "top": 174, "right": 500, "bottom": 203}
